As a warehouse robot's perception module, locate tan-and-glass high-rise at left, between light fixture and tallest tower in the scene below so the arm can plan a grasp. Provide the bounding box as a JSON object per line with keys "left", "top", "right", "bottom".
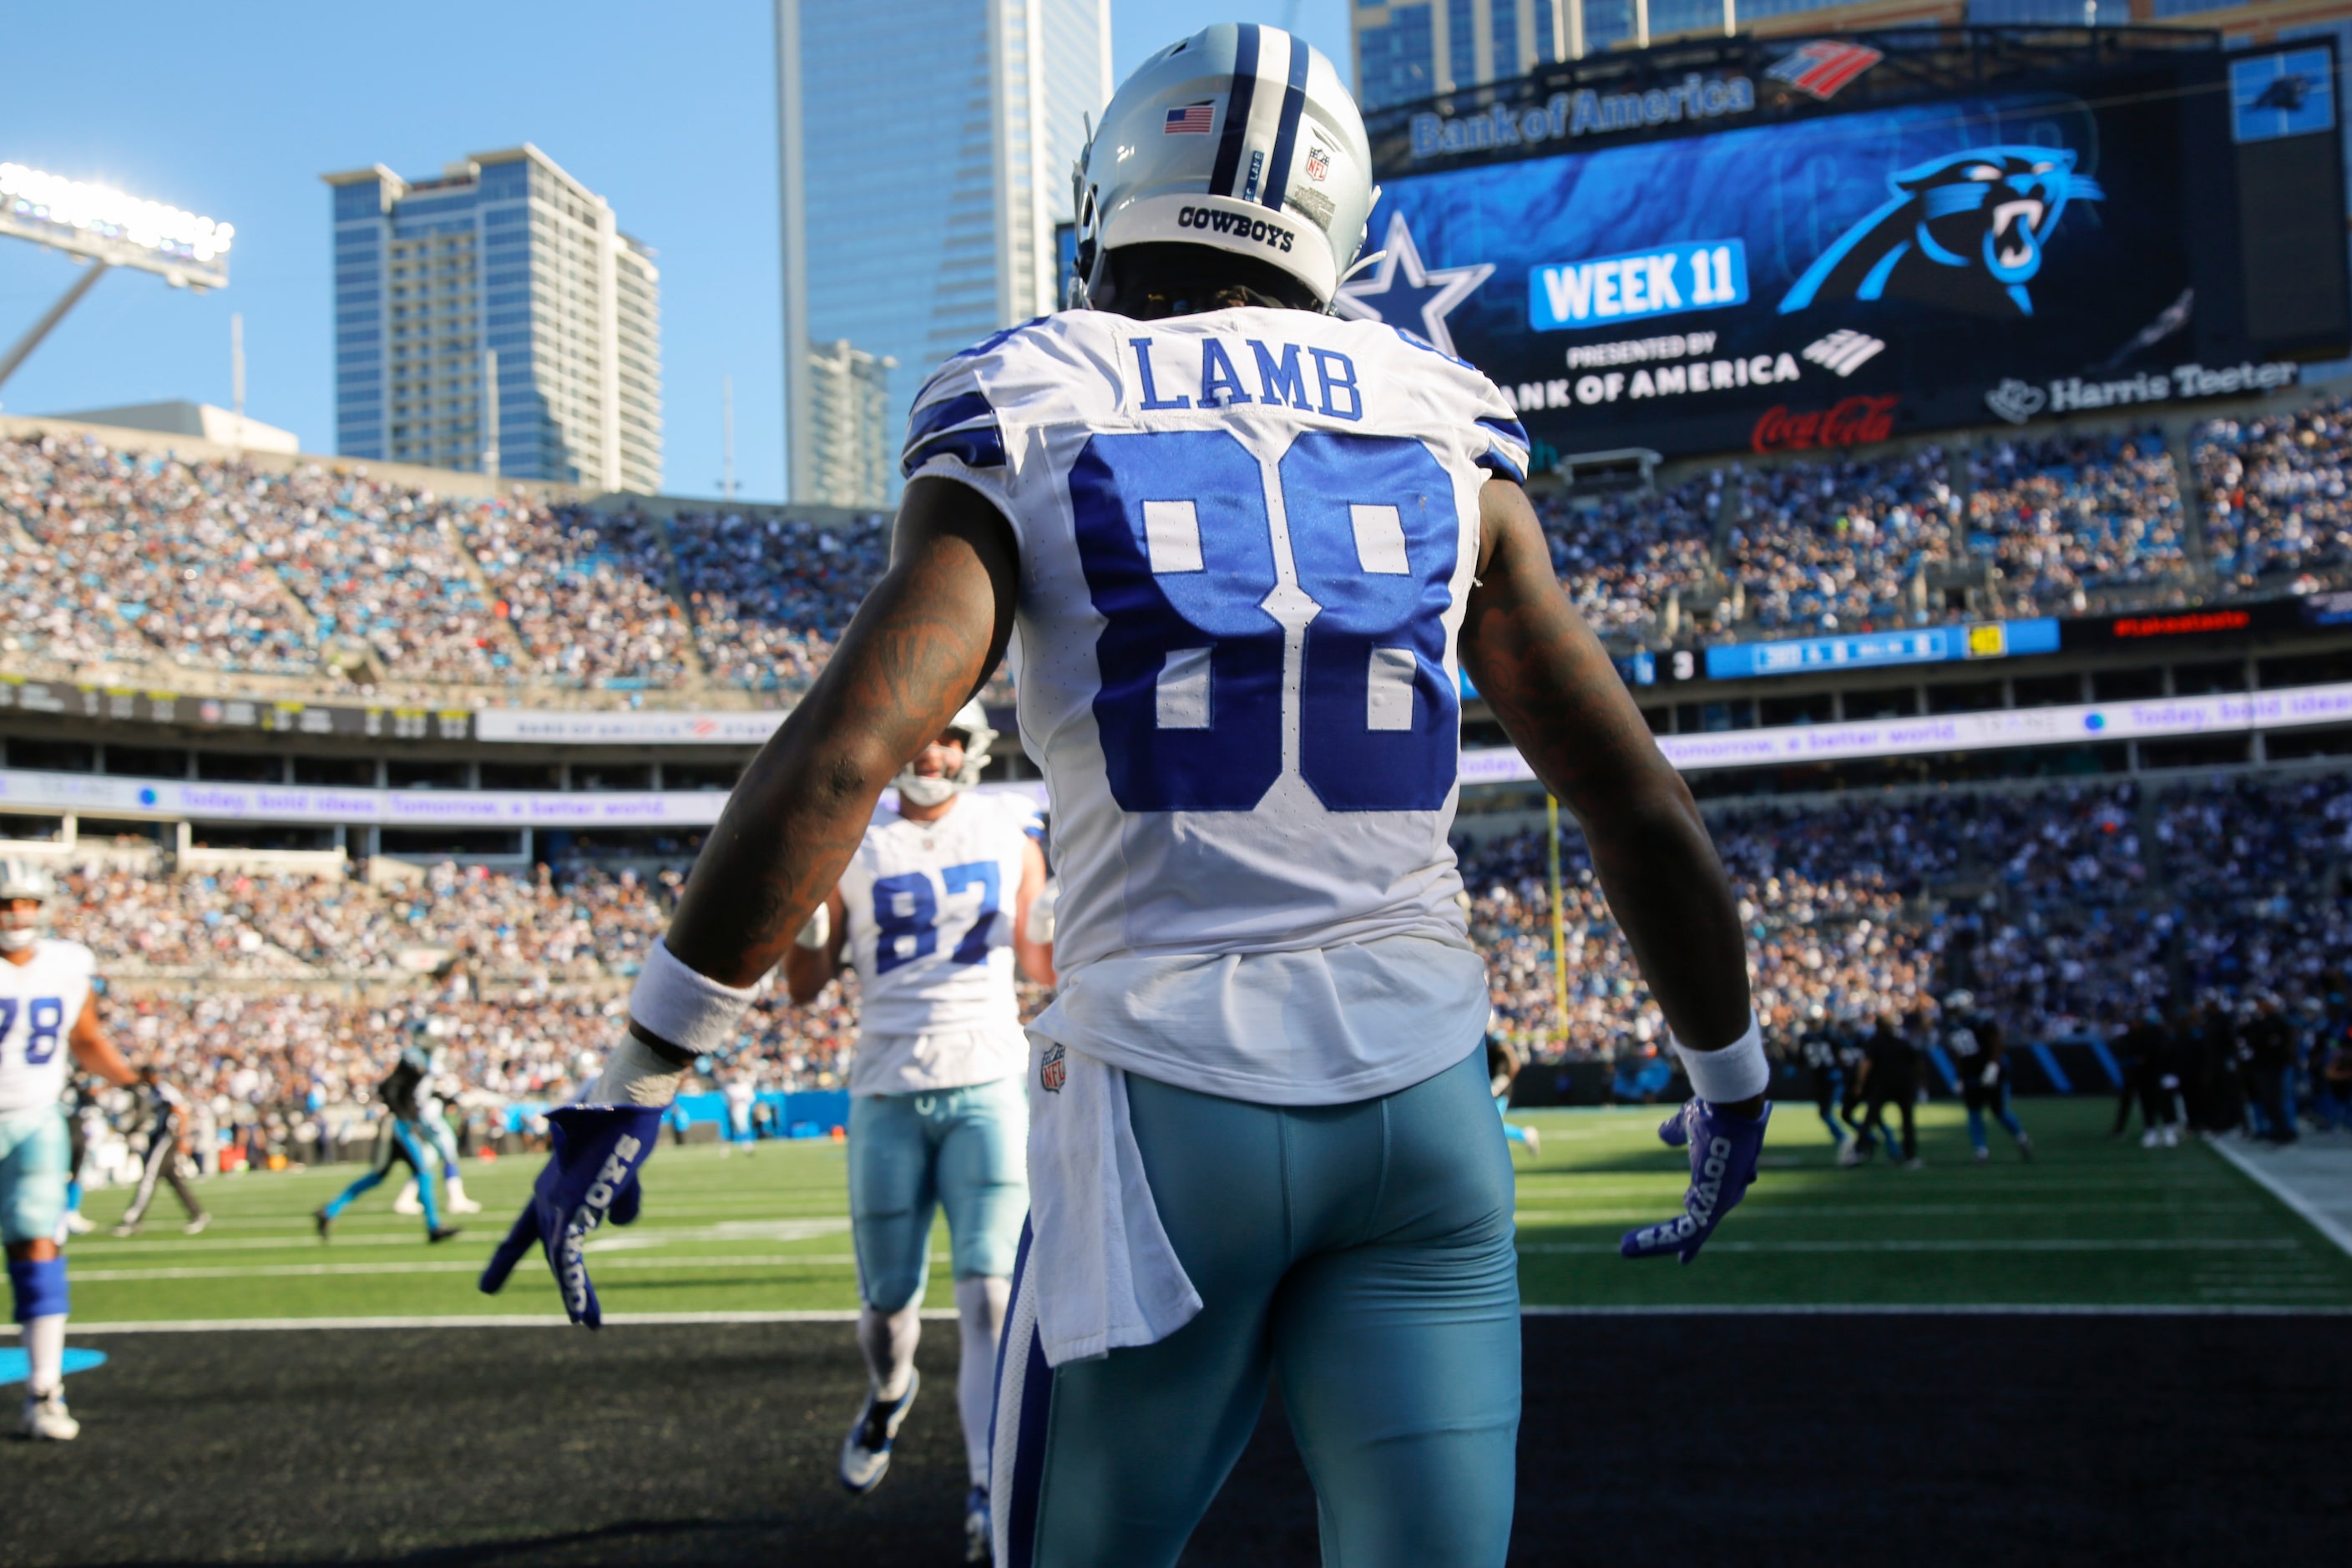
{"left": 325, "top": 144, "right": 661, "bottom": 493}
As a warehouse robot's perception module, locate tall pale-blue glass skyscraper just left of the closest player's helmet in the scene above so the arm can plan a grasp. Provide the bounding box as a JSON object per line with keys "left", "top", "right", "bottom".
{"left": 776, "top": 0, "right": 1110, "bottom": 501}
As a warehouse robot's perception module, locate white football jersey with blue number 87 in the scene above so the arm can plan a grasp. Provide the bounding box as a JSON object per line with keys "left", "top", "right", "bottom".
{"left": 840, "top": 790, "right": 1039, "bottom": 1093}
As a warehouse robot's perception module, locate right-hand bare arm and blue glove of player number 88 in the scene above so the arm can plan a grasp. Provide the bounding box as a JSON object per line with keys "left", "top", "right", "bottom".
{"left": 1460, "top": 479, "right": 1768, "bottom": 1262}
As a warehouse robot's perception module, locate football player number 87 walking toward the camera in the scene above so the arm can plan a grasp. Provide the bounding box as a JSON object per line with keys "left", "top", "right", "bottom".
{"left": 783, "top": 703, "right": 1054, "bottom": 1554}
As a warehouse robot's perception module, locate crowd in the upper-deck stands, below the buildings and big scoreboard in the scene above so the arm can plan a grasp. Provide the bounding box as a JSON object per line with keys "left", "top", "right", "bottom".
{"left": 0, "top": 400, "right": 2352, "bottom": 701}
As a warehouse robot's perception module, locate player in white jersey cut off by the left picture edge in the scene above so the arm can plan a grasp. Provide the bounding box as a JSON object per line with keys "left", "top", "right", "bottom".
{"left": 0, "top": 861, "right": 136, "bottom": 1441}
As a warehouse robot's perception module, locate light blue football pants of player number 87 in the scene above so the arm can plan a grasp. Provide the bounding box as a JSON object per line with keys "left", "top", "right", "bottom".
{"left": 849, "top": 1077, "right": 1028, "bottom": 1312}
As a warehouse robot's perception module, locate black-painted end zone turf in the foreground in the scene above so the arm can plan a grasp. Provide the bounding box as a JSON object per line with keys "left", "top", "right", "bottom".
{"left": 0, "top": 1317, "right": 2352, "bottom": 1568}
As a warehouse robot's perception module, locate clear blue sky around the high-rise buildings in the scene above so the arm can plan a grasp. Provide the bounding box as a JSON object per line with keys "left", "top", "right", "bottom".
{"left": 0, "top": 0, "right": 1348, "bottom": 498}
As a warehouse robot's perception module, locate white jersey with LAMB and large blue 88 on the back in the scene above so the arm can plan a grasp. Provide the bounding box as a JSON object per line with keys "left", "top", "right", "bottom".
{"left": 906, "top": 308, "right": 1526, "bottom": 1103}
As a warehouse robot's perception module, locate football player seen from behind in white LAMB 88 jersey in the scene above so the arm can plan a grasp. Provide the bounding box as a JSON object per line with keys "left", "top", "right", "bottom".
{"left": 484, "top": 23, "right": 1768, "bottom": 1568}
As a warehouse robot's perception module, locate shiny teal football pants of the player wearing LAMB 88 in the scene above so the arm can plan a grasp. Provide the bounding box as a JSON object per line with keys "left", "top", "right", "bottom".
{"left": 993, "top": 1053, "right": 1520, "bottom": 1568}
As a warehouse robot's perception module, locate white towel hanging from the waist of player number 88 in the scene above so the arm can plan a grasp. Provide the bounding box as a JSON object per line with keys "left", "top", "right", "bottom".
{"left": 1028, "top": 1032, "right": 1200, "bottom": 1366}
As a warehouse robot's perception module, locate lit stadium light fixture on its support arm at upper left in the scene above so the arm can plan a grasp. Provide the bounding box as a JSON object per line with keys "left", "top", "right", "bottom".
{"left": 0, "top": 162, "right": 238, "bottom": 399}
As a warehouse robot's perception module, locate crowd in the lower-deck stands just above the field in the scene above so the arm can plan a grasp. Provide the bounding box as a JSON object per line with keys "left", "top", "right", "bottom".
{"left": 37, "top": 773, "right": 2352, "bottom": 1171}
